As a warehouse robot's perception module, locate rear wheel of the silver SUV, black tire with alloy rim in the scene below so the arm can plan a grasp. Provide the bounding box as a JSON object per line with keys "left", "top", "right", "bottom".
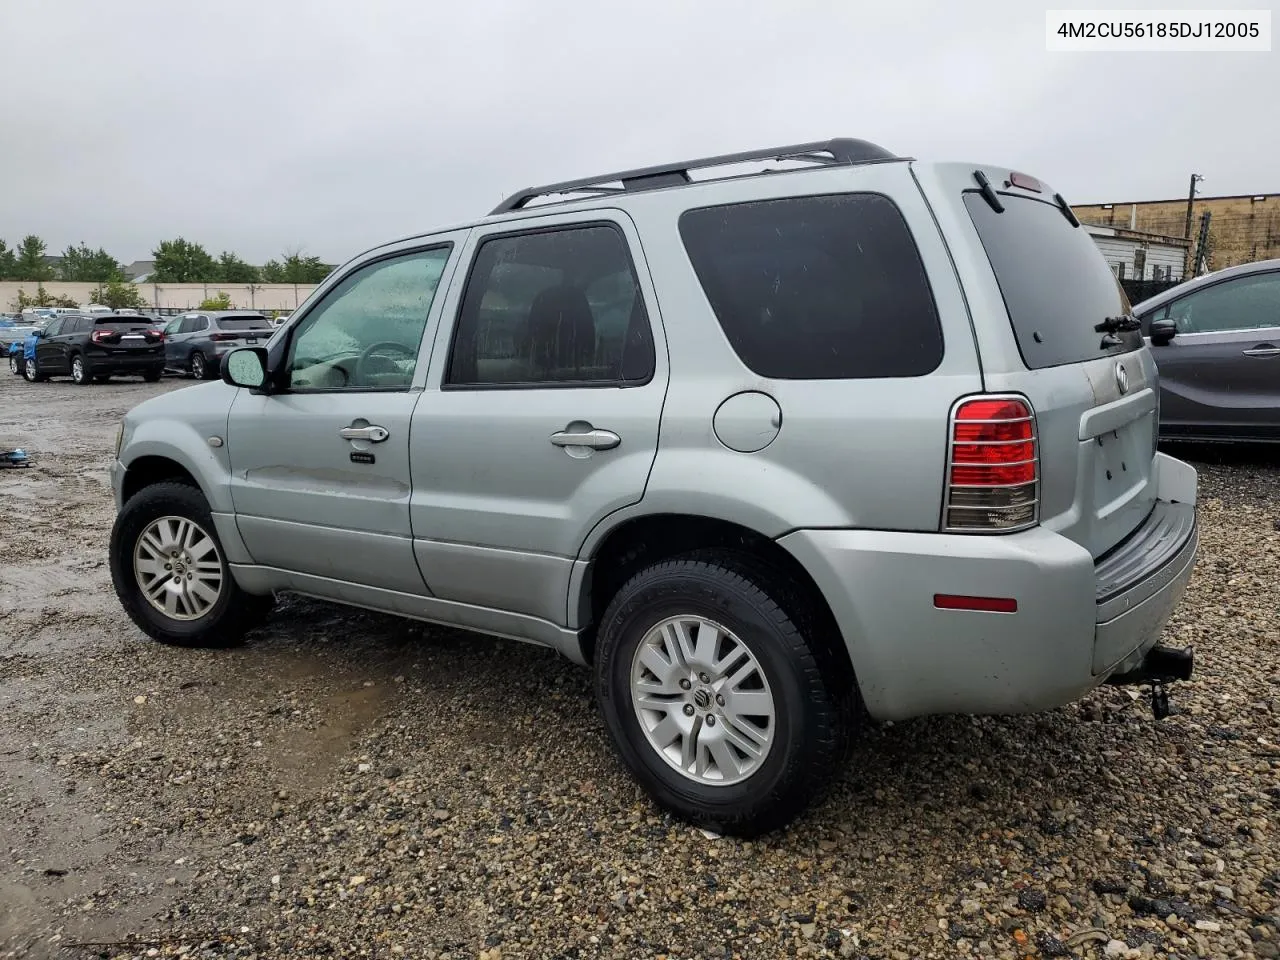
{"left": 595, "top": 552, "right": 858, "bottom": 837}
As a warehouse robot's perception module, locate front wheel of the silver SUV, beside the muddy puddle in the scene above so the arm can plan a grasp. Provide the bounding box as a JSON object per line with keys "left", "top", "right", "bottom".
{"left": 109, "top": 481, "right": 274, "bottom": 648}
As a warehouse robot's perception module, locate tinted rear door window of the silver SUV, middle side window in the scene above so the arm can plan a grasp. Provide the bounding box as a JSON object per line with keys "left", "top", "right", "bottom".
{"left": 447, "top": 224, "right": 654, "bottom": 387}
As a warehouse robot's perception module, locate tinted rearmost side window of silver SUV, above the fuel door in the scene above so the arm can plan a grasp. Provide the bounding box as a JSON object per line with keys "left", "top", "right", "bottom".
{"left": 680, "top": 193, "right": 942, "bottom": 380}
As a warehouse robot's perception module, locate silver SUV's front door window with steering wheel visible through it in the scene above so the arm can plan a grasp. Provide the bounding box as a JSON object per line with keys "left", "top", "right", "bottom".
{"left": 288, "top": 246, "right": 452, "bottom": 390}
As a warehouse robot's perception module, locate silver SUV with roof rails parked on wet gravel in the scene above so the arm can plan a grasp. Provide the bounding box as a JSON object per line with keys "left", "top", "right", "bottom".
{"left": 110, "top": 140, "right": 1197, "bottom": 835}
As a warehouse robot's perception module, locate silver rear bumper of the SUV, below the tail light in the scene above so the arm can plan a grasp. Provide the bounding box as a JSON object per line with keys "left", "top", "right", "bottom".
{"left": 780, "top": 454, "right": 1198, "bottom": 719}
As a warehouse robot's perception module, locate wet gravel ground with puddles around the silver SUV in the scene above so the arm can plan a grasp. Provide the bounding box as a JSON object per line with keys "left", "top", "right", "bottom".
{"left": 0, "top": 375, "right": 1280, "bottom": 960}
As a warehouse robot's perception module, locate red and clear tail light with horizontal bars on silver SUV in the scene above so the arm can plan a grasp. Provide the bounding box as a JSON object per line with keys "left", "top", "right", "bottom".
{"left": 943, "top": 397, "right": 1039, "bottom": 532}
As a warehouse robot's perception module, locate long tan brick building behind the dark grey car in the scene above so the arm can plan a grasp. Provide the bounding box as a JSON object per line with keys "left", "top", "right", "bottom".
{"left": 1071, "top": 193, "right": 1280, "bottom": 270}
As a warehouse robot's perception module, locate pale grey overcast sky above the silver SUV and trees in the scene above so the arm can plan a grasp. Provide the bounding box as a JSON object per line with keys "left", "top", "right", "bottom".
{"left": 0, "top": 0, "right": 1280, "bottom": 262}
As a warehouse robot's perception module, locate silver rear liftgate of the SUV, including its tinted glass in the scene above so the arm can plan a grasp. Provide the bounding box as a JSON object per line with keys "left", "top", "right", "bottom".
{"left": 922, "top": 164, "right": 1158, "bottom": 558}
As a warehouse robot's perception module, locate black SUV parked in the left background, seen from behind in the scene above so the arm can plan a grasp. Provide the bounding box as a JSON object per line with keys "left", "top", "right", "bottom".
{"left": 23, "top": 314, "right": 164, "bottom": 385}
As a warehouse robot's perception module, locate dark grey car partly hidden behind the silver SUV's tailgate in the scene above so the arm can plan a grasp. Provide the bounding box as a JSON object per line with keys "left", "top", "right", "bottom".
{"left": 1133, "top": 260, "right": 1280, "bottom": 443}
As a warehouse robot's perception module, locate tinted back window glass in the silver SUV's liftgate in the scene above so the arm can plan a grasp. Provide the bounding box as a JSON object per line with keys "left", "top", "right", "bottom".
{"left": 964, "top": 191, "right": 1142, "bottom": 370}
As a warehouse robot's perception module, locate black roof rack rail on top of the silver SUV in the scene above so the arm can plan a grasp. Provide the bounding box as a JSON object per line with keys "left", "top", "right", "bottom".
{"left": 490, "top": 137, "right": 901, "bottom": 216}
